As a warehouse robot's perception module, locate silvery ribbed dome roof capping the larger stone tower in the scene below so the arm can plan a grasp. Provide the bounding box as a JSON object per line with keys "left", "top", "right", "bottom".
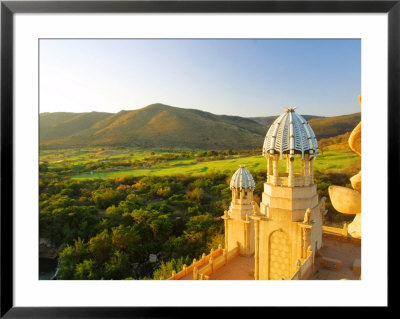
{"left": 263, "top": 108, "right": 318, "bottom": 157}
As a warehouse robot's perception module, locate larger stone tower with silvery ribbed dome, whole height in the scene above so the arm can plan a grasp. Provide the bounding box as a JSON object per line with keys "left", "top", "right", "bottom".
{"left": 252, "top": 108, "right": 322, "bottom": 280}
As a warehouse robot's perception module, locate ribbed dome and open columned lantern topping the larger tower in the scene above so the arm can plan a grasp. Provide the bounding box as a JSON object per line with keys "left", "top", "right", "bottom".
{"left": 263, "top": 108, "right": 318, "bottom": 187}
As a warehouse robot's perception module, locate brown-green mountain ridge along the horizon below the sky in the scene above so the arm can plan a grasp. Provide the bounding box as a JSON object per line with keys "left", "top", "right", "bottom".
{"left": 40, "top": 103, "right": 361, "bottom": 149}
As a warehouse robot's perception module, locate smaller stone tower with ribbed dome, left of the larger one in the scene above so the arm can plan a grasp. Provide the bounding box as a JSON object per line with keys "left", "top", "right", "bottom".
{"left": 222, "top": 165, "right": 255, "bottom": 256}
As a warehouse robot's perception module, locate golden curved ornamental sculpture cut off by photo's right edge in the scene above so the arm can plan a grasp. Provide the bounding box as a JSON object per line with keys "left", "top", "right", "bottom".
{"left": 329, "top": 95, "right": 361, "bottom": 238}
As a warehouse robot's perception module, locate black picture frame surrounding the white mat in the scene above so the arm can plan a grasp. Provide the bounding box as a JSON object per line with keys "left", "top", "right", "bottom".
{"left": 0, "top": 0, "right": 394, "bottom": 318}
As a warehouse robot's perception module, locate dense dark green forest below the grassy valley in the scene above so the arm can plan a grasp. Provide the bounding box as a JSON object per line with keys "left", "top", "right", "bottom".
{"left": 39, "top": 153, "right": 353, "bottom": 279}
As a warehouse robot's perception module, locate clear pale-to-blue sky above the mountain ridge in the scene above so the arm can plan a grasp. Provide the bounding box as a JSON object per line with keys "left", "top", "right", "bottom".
{"left": 39, "top": 39, "right": 361, "bottom": 117}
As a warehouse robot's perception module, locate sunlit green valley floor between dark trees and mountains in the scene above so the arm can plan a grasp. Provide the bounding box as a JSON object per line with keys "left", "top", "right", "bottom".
{"left": 40, "top": 148, "right": 361, "bottom": 180}
